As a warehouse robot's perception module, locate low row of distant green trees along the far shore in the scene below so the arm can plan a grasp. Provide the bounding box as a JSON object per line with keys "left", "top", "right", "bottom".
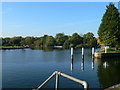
{"left": 2, "top": 32, "right": 98, "bottom": 48}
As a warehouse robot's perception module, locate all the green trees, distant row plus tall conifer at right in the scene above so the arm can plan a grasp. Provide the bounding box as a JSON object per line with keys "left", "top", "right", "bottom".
{"left": 2, "top": 3, "right": 120, "bottom": 48}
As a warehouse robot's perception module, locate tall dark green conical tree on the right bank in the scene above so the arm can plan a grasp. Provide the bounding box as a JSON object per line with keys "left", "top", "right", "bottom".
{"left": 98, "top": 3, "right": 120, "bottom": 46}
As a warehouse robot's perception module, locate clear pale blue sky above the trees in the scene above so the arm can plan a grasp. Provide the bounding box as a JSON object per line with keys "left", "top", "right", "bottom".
{"left": 2, "top": 2, "right": 118, "bottom": 37}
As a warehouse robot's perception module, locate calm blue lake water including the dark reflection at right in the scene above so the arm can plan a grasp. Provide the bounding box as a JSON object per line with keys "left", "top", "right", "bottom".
{"left": 2, "top": 49, "right": 120, "bottom": 88}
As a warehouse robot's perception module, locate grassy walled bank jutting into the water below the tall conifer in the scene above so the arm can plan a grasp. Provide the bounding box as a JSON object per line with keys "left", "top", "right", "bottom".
{"left": 94, "top": 48, "right": 120, "bottom": 58}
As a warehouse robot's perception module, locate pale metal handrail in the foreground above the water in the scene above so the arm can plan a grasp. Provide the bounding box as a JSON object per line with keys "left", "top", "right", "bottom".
{"left": 34, "top": 71, "right": 88, "bottom": 90}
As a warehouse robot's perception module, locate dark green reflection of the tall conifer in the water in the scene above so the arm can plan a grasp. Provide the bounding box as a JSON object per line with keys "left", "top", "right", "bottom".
{"left": 95, "top": 58, "right": 120, "bottom": 88}
